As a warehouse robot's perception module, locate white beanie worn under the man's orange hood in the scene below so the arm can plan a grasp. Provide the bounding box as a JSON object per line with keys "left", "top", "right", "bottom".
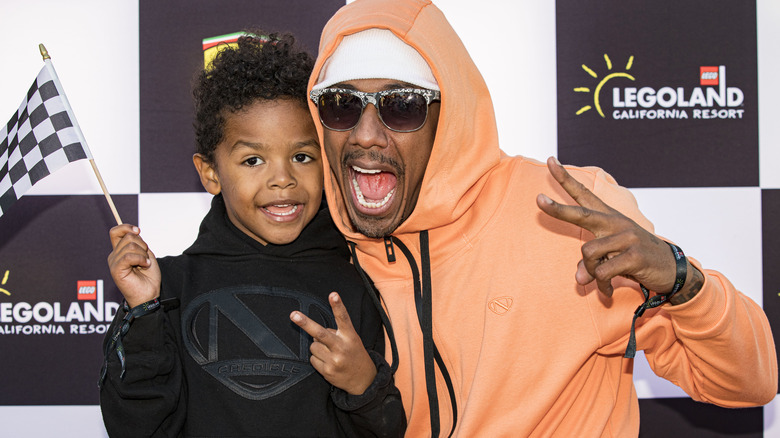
{"left": 312, "top": 29, "right": 439, "bottom": 91}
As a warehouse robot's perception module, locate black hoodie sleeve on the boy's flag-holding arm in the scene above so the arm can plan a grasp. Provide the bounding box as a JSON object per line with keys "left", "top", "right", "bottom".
{"left": 100, "top": 302, "right": 186, "bottom": 438}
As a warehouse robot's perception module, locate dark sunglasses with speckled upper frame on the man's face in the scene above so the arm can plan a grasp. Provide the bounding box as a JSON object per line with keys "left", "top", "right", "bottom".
{"left": 311, "top": 88, "right": 441, "bottom": 132}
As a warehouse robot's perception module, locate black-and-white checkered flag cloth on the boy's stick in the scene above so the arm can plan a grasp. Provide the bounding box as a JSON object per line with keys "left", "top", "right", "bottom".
{"left": 0, "top": 62, "right": 89, "bottom": 216}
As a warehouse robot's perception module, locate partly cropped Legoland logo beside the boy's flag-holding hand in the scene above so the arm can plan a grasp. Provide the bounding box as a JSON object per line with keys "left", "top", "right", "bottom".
{"left": 0, "top": 280, "right": 119, "bottom": 335}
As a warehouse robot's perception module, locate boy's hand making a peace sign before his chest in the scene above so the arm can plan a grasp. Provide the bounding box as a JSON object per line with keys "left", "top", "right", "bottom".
{"left": 290, "top": 292, "right": 376, "bottom": 395}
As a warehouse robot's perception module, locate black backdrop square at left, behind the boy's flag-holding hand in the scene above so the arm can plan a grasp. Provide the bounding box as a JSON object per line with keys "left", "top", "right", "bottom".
{"left": 0, "top": 195, "right": 138, "bottom": 405}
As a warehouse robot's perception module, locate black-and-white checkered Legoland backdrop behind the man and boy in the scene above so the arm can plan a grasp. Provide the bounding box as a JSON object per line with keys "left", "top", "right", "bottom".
{"left": 0, "top": 0, "right": 780, "bottom": 437}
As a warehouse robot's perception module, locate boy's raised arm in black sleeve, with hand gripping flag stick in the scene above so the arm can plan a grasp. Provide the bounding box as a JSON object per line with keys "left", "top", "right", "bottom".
{"left": 98, "top": 228, "right": 186, "bottom": 438}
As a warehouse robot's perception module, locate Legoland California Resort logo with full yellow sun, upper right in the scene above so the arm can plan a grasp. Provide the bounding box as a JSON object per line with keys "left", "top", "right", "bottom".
{"left": 574, "top": 54, "right": 745, "bottom": 120}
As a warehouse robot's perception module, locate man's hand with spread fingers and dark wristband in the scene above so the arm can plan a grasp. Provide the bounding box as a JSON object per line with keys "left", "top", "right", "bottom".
{"left": 536, "top": 157, "right": 703, "bottom": 304}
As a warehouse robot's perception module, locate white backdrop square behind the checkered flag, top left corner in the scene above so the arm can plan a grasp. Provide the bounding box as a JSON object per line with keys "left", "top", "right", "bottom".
{"left": 0, "top": 0, "right": 140, "bottom": 195}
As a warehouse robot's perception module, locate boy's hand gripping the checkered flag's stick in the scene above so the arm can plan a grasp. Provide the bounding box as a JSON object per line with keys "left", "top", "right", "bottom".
{"left": 108, "top": 224, "right": 162, "bottom": 308}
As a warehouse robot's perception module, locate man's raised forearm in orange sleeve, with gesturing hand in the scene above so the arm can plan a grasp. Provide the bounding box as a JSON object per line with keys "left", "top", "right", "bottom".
{"left": 537, "top": 158, "right": 778, "bottom": 407}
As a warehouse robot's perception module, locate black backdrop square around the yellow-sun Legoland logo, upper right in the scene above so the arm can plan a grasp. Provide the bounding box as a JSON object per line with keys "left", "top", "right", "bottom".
{"left": 556, "top": 0, "right": 758, "bottom": 187}
